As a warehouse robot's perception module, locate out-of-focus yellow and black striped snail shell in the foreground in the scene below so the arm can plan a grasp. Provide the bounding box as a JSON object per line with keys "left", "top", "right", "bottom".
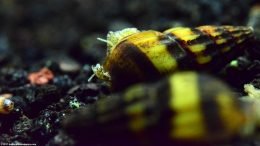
{"left": 64, "top": 72, "right": 253, "bottom": 145}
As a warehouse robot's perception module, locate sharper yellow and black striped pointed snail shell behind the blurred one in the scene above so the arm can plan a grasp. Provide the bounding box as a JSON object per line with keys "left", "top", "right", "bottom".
{"left": 96, "top": 26, "right": 253, "bottom": 91}
